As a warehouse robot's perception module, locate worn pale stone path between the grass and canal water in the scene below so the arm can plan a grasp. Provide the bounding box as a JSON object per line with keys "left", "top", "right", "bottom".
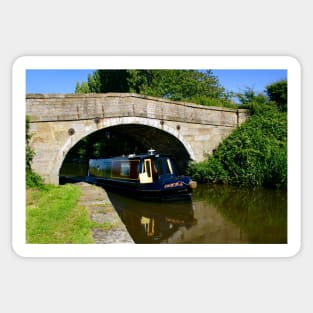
{"left": 76, "top": 183, "right": 134, "bottom": 243}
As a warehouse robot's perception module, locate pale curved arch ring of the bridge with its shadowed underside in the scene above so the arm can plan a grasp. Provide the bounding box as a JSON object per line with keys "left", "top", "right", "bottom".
{"left": 55, "top": 117, "right": 195, "bottom": 181}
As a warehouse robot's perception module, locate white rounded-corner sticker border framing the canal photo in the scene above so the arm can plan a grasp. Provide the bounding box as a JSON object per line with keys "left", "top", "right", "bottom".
{"left": 11, "top": 56, "right": 301, "bottom": 258}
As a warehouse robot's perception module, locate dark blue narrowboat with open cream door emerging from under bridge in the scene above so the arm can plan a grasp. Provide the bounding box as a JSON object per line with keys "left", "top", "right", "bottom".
{"left": 86, "top": 149, "right": 197, "bottom": 200}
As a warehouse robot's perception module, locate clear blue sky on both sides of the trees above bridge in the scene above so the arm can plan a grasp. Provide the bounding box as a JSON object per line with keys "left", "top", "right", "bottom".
{"left": 26, "top": 69, "right": 287, "bottom": 94}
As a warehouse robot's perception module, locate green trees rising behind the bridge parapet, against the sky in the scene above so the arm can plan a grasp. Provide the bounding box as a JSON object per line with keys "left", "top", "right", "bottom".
{"left": 75, "top": 70, "right": 234, "bottom": 107}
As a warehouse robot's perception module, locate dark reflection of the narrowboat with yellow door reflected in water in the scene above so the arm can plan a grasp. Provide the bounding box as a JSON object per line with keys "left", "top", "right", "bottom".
{"left": 107, "top": 191, "right": 197, "bottom": 243}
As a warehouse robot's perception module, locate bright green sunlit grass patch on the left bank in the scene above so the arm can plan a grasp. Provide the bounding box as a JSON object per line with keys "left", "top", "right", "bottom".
{"left": 26, "top": 185, "right": 95, "bottom": 244}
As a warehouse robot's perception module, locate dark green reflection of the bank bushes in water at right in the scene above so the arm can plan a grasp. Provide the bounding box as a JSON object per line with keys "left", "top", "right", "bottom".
{"left": 194, "top": 186, "right": 287, "bottom": 244}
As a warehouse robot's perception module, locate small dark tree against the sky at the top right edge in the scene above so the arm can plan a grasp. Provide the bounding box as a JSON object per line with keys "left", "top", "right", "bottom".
{"left": 266, "top": 80, "right": 288, "bottom": 112}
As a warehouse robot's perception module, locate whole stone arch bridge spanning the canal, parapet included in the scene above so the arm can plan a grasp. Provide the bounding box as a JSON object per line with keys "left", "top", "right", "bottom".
{"left": 26, "top": 93, "right": 248, "bottom": 184}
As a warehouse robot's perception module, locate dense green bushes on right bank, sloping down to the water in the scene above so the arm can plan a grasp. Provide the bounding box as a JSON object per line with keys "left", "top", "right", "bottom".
{"left": 188, "top": 105, "right": 287, "bottom": 188}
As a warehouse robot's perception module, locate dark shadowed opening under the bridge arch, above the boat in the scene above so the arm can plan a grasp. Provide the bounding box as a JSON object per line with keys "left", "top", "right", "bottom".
{"left": 59, "top": 124, "right": 191, "bottom": 184}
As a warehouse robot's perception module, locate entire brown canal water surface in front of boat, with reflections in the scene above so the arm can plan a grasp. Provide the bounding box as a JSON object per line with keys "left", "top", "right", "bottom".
{"left": 108, "top": 185, "right": 287, "bottom": 243}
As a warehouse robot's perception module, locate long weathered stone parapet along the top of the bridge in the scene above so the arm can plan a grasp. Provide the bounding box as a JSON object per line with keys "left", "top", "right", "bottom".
{"left": 26, "top": 93, "right": 247, "bottom": 127}
